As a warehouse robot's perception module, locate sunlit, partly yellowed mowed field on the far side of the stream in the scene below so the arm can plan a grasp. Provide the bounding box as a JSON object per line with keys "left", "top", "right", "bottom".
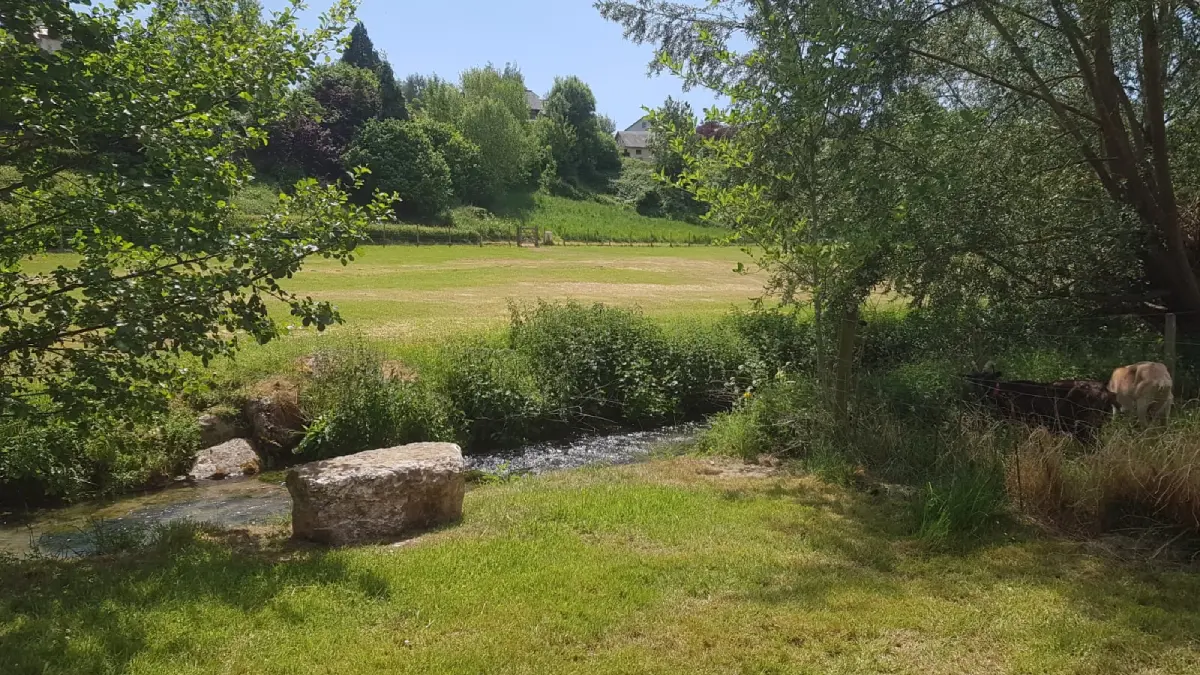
{"left": 24, "top": 245, "right": 764, "bottom": 344}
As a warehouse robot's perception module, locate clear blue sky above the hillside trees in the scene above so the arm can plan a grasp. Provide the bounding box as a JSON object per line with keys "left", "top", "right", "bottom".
{"left": 272, "top": 0, "right": 716, "bottom": 129}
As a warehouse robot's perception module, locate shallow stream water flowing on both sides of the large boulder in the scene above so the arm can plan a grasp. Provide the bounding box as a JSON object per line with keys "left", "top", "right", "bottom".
{"left": 0, "top": 425, "right": 696, "bottom": 556}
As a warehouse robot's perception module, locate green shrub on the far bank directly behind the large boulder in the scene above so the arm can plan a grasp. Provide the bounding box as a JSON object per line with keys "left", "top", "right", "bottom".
{"left": 295, "top": 346, "right": 454, "bottom": 459}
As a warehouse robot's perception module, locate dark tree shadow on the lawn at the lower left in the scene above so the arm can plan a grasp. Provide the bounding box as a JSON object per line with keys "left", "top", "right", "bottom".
{"left": 0, "top": 522, "right": 388, "bottom": 674}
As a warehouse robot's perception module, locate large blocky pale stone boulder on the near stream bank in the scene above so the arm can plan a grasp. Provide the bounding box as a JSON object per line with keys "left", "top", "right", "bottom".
{"left": 287, "top": 443, "right": 466, "bottom": 546}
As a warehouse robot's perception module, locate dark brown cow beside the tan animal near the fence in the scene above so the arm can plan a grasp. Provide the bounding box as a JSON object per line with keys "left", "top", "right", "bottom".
{"left": 965, "top": 372, "right": 1117, "bottom": 444}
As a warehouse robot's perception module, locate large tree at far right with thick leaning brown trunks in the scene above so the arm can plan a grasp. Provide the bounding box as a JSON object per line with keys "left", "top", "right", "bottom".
{"left": 598, "top": 0, "right": 1200, "bottom": 330}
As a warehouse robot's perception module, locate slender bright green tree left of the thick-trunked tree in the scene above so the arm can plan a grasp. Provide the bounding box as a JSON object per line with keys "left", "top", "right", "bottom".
{"left": 602, "top": 0, "right": 907, "bottom": 376}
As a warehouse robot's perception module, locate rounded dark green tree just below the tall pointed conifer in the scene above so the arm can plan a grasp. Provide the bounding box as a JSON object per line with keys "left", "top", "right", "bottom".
{"left": 344, "top": 120, "right": 454, "bottom": 217}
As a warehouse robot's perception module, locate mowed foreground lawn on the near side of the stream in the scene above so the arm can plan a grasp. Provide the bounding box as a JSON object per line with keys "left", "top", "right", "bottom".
{"left": 0, "top": 458, "right": 1200, "bottom": 675}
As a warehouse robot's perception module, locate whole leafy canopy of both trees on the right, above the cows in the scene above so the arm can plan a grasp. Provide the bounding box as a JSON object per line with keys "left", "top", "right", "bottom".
{"left": 598, "top": 0, "right": 1200, "bottom": 329}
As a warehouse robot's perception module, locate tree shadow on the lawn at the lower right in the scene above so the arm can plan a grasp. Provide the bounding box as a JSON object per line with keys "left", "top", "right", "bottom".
{"left": 742, "top": 475, "right": 1200, "bottom": 667}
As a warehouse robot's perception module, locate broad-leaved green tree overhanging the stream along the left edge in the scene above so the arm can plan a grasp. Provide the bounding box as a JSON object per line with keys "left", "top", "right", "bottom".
{"left": 0, "top": 0, "right": 383, "bottom": 418}
